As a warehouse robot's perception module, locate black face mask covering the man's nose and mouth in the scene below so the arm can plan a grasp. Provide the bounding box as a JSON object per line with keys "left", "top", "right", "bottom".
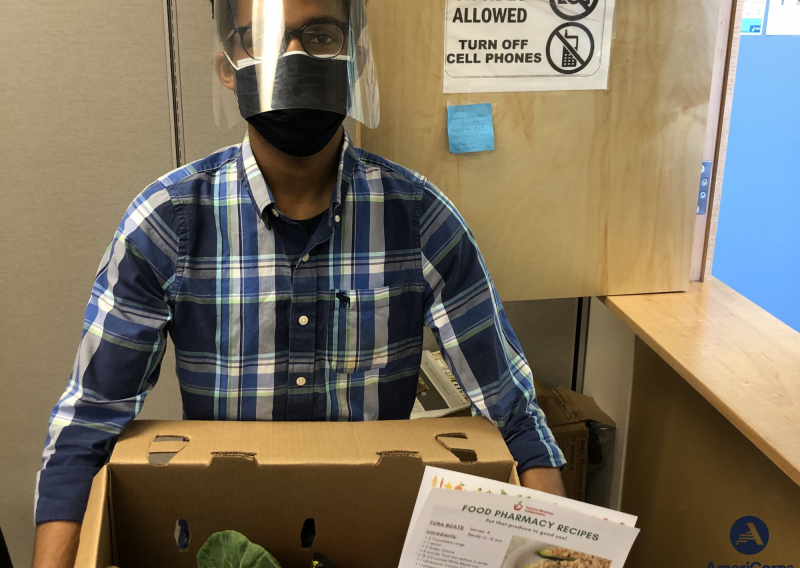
{"left": 236, "top": 53, "right": 348, "bottom": 157}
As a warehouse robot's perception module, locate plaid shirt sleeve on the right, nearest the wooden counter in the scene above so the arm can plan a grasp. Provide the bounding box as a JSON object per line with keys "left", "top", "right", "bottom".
{"left": 420, "top": 182, "right": 566, "bottom": 473}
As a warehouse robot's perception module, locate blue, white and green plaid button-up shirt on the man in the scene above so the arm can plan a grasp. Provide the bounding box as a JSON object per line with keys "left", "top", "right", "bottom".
{"left": 36, "top": 132, "right": 564, "bottom": 522}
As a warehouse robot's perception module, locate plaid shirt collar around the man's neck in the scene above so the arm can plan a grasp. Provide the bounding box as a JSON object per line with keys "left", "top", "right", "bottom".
{"left": 238, "top": 127, "right": 359, "bottom": 226}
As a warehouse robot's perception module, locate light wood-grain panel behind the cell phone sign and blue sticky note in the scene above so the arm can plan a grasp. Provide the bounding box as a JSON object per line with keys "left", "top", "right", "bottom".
{"left": 362, "top": 0, "right": 721, "bottom": 300}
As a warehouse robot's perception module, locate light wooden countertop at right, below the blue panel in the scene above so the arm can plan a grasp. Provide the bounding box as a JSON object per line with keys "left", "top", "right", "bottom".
{"left": 602, "top": 278, "right": 800, "bottom": 485}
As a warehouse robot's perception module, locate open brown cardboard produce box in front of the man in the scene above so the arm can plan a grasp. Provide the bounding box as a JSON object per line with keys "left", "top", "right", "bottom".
{"left": 76, "top": 418, "right": 519, "bottom": 568}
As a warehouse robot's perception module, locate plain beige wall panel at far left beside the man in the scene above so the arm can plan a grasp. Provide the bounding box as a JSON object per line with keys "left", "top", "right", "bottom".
{"left": 0, "top": 0, "right": 180, "bottom": 566}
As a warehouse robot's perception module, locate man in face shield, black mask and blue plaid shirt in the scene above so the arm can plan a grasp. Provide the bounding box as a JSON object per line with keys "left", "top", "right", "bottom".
{"left": 34, "top": 0, "right": 564, "bottom": 568}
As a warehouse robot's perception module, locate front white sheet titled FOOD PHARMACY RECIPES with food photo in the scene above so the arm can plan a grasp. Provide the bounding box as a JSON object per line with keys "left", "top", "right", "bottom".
{"left": 399, "top": 487, "right": 639, "bottom": 568}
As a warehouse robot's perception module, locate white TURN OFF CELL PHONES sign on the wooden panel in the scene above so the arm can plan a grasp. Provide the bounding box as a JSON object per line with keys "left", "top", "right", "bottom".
{"left": 444, "top": 0, "right": 614, "bottom": 93}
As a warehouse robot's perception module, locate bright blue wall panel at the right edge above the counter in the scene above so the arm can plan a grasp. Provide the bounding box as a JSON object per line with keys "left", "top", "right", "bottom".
{"left": 712, "top": 8, "right": 800, "bottom": 331}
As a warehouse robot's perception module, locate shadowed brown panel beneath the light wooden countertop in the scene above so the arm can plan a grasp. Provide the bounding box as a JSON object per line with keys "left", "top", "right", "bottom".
{"left": 622, "top": 338, "right": 800, "bottom": 567}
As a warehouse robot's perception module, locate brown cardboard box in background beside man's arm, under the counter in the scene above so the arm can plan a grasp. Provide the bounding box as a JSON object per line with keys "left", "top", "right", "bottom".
{"left": 535, "top": 385, "right": 616, "bottom": 501}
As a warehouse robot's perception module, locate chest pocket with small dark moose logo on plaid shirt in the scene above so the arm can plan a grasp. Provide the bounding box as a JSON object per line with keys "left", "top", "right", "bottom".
{"left": 328, "top": 285, "right": 422, "bottom": 373}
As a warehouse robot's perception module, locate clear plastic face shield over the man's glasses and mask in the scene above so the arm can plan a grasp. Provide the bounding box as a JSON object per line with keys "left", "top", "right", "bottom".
{"left": 212, "top": 0, "right": 380, "bottom": 128}
